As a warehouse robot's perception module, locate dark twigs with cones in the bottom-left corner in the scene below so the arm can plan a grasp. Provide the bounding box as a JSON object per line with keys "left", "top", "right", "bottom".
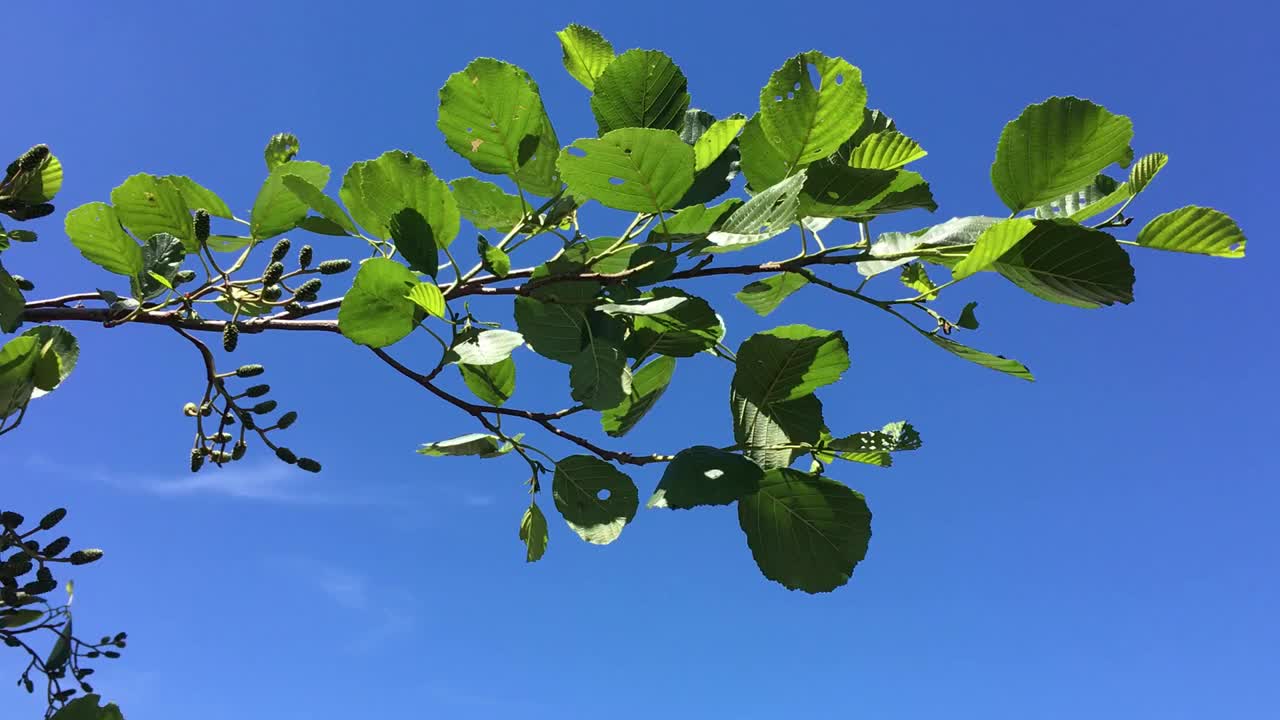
{"left": 0, "top": 507, "right": 128, "bottom": 717}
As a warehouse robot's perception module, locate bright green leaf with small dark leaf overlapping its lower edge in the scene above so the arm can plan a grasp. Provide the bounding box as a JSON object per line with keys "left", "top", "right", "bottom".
{"left": 340, "top": 150, "right": 461, "bottom": 247}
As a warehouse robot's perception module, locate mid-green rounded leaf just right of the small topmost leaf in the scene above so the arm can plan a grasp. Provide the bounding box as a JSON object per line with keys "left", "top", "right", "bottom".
{"left": 588, "top": 50, "right": 689, "bottom": 133}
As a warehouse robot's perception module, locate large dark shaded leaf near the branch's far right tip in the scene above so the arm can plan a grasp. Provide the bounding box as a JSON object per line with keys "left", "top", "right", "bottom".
{"left": 995, "top": 219, "right": 1134, "bottom": 307}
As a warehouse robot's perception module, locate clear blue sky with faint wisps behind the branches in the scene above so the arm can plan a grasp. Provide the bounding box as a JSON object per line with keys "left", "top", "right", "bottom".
{"left": 0, "top": 0, "right": 1280, "bottom": 720}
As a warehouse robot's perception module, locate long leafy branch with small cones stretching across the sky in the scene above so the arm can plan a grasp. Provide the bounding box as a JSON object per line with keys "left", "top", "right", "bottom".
{"left": 0, "top": 26, "right": 1244, "bottom": 592}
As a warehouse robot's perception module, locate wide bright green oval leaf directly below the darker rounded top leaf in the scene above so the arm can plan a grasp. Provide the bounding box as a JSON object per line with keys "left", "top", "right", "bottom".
{"left": 559, "top": 128, "right": 694, "bottom": 213}
